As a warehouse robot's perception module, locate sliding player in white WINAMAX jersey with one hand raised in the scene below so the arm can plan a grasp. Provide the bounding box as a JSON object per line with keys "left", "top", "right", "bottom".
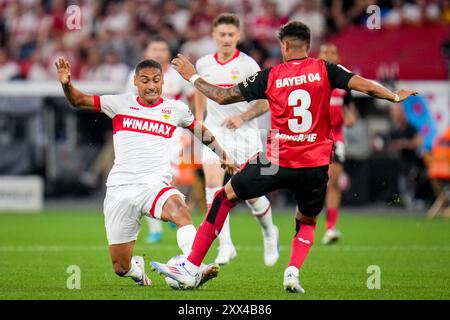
{"left": 55, "top": 58, "right": 236, "bottom": 285}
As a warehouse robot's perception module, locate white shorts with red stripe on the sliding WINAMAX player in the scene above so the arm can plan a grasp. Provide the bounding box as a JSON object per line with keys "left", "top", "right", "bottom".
{"left": 103, "top": 181, "right": 185, "bottom": 245}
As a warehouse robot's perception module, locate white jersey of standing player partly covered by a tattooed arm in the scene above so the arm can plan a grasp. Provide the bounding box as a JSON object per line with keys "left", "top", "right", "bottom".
{"left": 196, "top": 50, "right": 262, "bottom": 163}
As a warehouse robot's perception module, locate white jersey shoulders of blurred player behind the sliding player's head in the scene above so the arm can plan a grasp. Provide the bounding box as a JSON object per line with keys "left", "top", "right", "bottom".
{"left": 125, "top": 66, "right": 195, "bottom": 101}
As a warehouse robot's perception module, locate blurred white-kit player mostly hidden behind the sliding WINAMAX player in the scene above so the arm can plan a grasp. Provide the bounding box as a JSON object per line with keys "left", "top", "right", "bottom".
{"left": 125, "top": 37, "right": 195, "bottom": 243}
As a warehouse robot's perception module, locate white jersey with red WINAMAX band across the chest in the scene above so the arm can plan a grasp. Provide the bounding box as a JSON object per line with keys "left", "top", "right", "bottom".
{"left": 94, "top": 93, "right": 195, "bottom": 186}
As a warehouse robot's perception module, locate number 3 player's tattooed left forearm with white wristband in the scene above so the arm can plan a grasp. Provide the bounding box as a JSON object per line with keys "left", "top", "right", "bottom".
{"left": 172, "top": 54, "right": 245, "bottom": 104}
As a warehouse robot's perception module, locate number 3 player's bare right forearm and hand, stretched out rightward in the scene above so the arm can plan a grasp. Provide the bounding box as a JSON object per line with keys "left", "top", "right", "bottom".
{"left": 348, "top": 75, "right": 417, "bottom": 102}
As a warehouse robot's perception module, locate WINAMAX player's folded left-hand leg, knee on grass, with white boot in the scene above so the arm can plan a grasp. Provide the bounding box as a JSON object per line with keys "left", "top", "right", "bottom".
{"left": 109, "top": 241, "right": 151, "bottom": 286}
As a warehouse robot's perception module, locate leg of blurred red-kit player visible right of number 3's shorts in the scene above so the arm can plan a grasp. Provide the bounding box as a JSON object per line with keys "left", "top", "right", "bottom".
{"left": 322, "top": 162, "right": 344, "bottom": 244}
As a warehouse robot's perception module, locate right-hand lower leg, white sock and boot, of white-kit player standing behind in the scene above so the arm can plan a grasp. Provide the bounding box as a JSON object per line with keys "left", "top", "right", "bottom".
{"left": 245, "top": 196, "right": 280, "bottom": 267}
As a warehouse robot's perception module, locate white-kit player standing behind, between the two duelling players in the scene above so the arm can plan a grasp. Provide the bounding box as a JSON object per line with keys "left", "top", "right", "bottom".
{"left": 195, "top": 13, "right": 279, "bottom": 266}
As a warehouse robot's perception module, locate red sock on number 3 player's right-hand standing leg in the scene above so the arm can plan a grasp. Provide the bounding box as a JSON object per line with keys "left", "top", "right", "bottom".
{"left": 289, "top": 221, "right": 316, "bottom": 269}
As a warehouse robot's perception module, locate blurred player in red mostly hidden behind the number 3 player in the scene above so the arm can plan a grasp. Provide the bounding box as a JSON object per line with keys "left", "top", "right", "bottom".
{"left": 319, "top": 43, "right": 356, "bottom": 245}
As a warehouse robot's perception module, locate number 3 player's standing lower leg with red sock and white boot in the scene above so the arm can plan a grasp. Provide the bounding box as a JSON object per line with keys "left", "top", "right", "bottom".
{"left": 283, "top": 208, "right": 317, "bottom": 293}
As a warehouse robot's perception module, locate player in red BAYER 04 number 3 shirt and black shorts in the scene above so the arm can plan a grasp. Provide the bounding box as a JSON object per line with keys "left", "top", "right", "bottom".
{"left": 152, "top": 21, "right": 417, "bottom": 292}
